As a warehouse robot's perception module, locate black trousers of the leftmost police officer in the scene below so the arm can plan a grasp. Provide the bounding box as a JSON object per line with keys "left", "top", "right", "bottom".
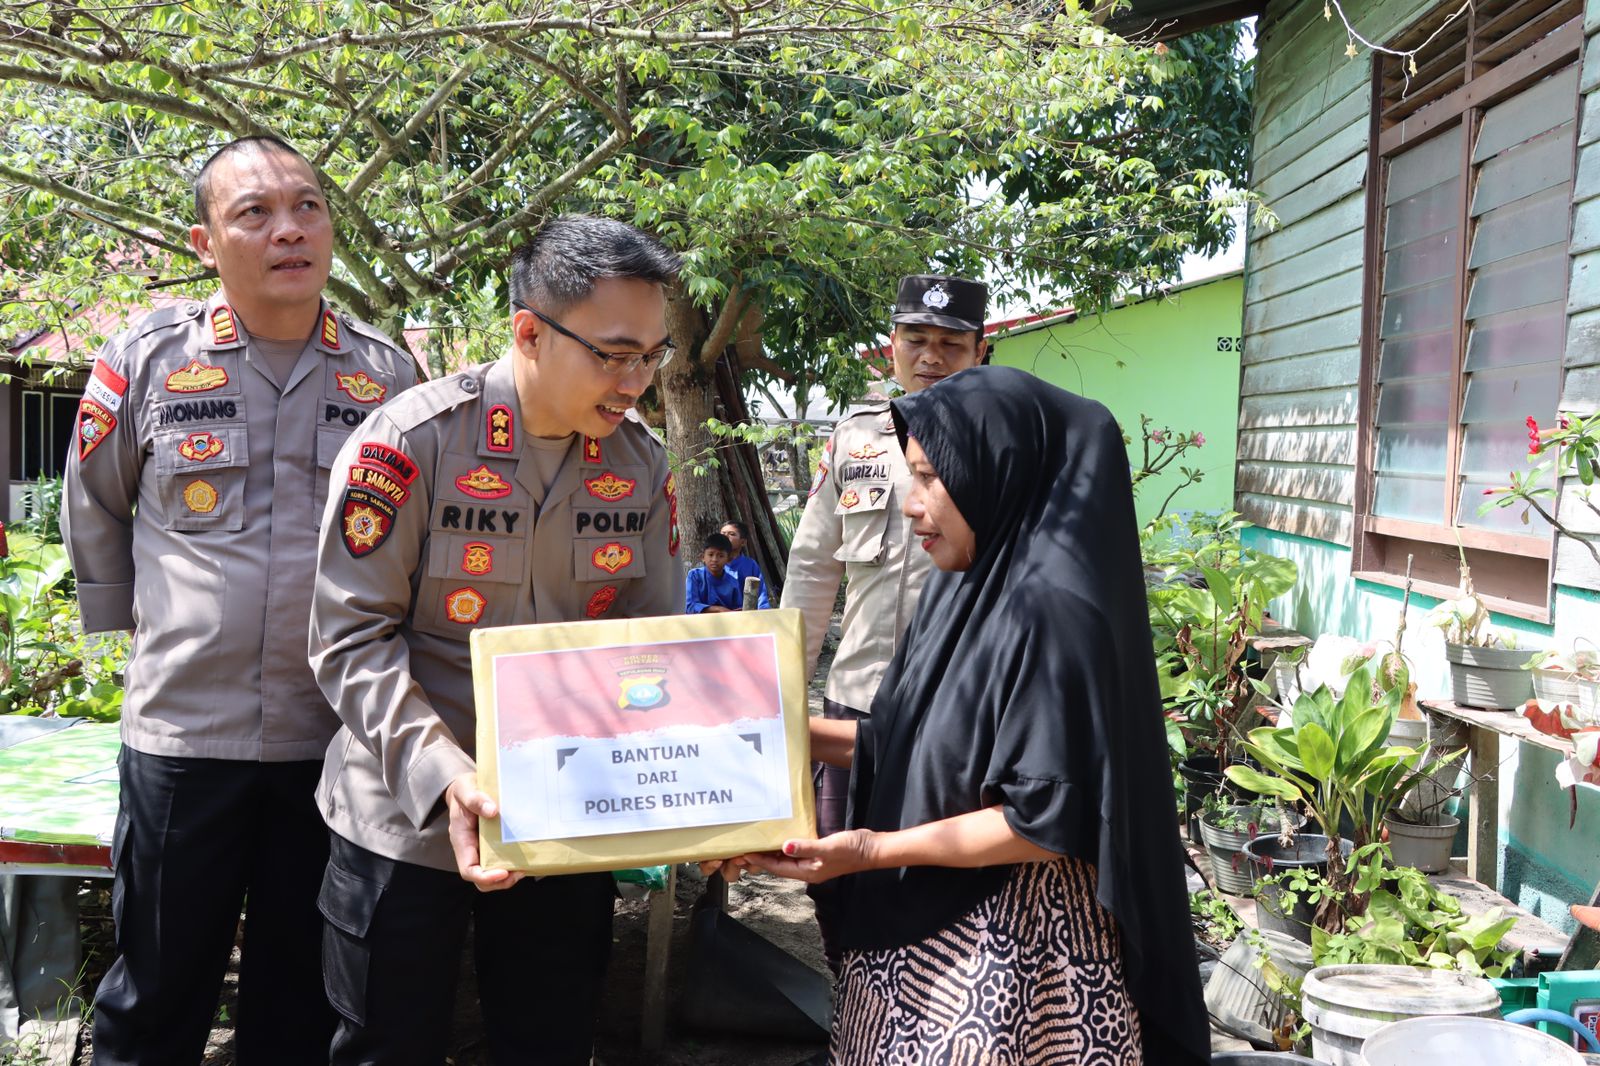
{"left": 94, "top": 747, "right": 334, "bottom": 1066}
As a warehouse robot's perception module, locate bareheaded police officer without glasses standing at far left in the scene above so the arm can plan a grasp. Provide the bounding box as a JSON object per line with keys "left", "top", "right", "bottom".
{"left": 61, "top": 138, "right": 416, "bottom": 1066}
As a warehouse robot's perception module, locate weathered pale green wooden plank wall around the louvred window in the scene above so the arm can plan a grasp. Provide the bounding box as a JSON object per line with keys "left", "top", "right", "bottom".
{"left": 1235, "top": 0, "right": 1600, "bottom": 930}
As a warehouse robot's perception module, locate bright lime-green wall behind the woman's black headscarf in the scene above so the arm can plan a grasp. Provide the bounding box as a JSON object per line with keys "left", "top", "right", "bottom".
{"left": 994, "top": 274, "right": 1245, "bottom": 522}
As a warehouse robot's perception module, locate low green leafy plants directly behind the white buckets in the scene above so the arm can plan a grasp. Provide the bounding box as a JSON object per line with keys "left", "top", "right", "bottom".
{"left": 1310, "top": 844, "right": 1517, "bottom": 978}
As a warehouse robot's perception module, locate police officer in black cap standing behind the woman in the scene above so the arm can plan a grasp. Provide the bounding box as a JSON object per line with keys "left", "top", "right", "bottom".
{"left": 782, "top": 275, "right": 989, "bottom": 964}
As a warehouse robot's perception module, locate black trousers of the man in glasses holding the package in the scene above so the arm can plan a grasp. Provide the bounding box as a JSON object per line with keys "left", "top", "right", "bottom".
{"left": 318, "top": 834, "right": 616, "bottom": 1066}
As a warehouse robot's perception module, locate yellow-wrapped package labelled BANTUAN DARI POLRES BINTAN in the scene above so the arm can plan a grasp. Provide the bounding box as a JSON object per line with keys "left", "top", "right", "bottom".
{"left": 472, "top": 610, "right": 816, "bottom": 874}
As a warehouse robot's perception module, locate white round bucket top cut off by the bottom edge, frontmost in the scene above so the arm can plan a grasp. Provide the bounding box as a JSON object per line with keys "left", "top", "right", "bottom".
{"left": 1362, "top": 1018, "right": 1584, "bottom": 1066}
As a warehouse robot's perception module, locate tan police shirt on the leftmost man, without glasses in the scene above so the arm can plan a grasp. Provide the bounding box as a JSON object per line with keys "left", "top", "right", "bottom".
{"left": 61, "top": 295, "right": 416, "bottom": 762}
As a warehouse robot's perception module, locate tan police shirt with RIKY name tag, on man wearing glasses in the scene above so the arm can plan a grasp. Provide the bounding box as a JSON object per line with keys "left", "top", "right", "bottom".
{"left": 310, "top": 359, "right": 683, "bottom": 871}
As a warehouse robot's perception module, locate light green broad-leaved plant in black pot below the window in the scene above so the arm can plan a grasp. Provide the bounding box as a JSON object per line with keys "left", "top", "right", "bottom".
{"left": 1227, "top": 664, "right": 1464, "bottom": 930}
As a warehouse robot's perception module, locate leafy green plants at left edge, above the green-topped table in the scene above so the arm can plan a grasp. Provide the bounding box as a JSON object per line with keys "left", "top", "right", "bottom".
{"left": 0, "top": 533, "right": 128, "bottom": 722}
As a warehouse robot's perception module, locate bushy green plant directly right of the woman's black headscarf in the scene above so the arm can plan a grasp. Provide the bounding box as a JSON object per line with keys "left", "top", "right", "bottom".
{"left": 1141, "top": 512, "right": 1299, "bottom": 765}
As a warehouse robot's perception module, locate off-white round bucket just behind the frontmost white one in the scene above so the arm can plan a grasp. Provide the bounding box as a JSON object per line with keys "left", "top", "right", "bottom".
{"left": 1301, "top": 965, "right": 1501, "bottom": 1066}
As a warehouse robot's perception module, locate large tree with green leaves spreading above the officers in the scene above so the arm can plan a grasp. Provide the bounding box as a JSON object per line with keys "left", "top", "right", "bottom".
{"left": 0, "top": 0, "right": 1238, "bottom": 563}
